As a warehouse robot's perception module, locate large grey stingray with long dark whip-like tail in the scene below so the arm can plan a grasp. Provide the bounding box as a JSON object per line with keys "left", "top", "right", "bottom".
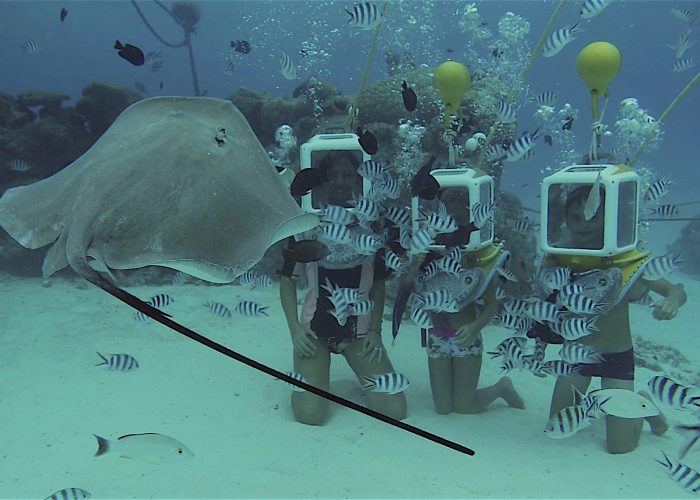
{"left": 0, "top": 97, "right": 474, "bottom": 455}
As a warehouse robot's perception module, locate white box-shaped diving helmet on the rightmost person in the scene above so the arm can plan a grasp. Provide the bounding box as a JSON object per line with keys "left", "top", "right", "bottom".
{"left": 539, "top": 164, "right": 640, "bottom": 257}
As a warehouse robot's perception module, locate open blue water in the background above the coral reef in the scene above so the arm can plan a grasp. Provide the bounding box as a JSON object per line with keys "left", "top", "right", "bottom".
{"left": 0, "top": 1, "right": 700, "bottom": 213}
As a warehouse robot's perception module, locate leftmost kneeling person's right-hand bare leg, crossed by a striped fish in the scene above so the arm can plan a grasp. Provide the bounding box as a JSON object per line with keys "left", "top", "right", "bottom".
{"left": 343, "top": 339, "right": 407, "bottom": 420}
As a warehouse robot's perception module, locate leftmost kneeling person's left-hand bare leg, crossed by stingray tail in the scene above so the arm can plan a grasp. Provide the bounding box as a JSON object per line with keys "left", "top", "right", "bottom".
{"left": 292, "top": 340, "right": 331, "bottom": 425}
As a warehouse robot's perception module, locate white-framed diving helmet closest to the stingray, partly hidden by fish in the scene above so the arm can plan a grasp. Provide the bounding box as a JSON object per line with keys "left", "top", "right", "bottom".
{"left": 299, "top": 132, "right": 372, "bottom": 212}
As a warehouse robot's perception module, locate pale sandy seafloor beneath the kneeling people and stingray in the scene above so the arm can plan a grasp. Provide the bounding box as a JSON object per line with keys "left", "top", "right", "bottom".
{"left": 0, "top": 268, "right": 700, "bottom": 498}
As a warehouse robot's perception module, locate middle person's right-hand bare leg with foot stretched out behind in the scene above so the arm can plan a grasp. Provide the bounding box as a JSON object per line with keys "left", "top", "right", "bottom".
{"left": 452, "top": 355, "right": 525, "bottom": 414}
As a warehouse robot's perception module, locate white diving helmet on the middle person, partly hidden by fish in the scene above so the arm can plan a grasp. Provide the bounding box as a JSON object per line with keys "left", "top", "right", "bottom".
{"left": 411, "top": 168, "right": 494, "bottom": 252}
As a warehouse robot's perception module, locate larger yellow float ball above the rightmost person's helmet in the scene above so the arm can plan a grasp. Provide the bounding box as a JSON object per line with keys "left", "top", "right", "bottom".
{"left": 576, "top": 42, "right": 622, "bottom": 96}
